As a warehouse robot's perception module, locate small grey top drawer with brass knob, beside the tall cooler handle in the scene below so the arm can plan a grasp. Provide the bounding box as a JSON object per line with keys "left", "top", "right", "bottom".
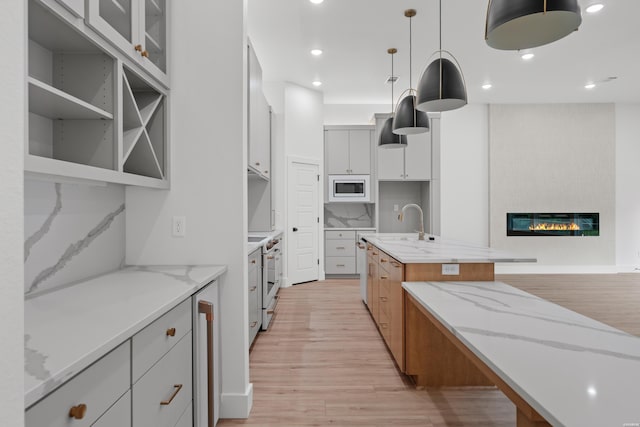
{"left": 131, "top": 299, "right": 191, "bottom": 383}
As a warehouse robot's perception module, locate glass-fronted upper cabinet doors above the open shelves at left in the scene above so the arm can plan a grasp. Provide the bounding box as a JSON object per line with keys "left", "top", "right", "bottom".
{"left": 86, "top": 0, "right": 169, "bottom": 86}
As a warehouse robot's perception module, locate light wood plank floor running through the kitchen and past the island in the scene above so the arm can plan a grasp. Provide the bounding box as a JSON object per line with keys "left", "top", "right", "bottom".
{"left": 218, "top": 274, "right": 640, "bottom": 427}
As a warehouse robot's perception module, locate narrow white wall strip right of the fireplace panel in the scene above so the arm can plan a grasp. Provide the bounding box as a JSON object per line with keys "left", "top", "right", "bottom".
{"left": 616, "top": 104, "right": 640, "bottom": 271}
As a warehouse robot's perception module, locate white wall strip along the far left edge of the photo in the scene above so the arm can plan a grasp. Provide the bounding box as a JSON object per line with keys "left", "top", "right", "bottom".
{"left": 0, "top": 1, "right": 27, "bottom": 427}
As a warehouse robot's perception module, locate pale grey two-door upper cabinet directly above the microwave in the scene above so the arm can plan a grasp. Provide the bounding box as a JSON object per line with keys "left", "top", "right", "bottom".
{"left": 324, "top": 126, "right": 373, "bottom": 175}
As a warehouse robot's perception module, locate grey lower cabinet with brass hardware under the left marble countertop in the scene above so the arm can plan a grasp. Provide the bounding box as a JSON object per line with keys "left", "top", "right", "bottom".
{"left": 25, "top": 286, "right": 220, "bottom": 427}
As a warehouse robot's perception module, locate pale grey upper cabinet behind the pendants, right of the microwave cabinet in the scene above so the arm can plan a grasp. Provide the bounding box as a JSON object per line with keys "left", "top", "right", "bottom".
{"left": 378, "top": 133, "right": 431, "bottom": 181}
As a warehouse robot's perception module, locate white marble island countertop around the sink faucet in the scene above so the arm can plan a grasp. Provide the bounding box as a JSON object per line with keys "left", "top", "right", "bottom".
{"left": 363, "top": 233, "right": 536, "bottom": 264}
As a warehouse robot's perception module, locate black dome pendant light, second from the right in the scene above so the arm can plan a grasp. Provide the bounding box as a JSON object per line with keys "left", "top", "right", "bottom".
{"left": 416, "top": 0, "right": 467, "bottom": 111}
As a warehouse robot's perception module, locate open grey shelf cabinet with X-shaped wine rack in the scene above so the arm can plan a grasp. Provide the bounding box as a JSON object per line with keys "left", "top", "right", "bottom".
{"left": 24, "top": 0, "right": 169, "bottom": 188}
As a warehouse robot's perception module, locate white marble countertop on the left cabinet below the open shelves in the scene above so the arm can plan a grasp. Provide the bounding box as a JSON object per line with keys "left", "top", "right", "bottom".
{"left": 24, "top": 266, "right": 227, "bottom": 408}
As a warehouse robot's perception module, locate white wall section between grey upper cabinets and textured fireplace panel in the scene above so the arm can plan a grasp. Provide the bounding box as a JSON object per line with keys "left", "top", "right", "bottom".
{"left": 440, "top": 104, "right": 489, "bottom": 245}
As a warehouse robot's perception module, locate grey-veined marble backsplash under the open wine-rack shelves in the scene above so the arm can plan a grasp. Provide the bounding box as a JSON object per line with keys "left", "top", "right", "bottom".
{"left": 24, "top": 180, "right": 125, "bottom": 296}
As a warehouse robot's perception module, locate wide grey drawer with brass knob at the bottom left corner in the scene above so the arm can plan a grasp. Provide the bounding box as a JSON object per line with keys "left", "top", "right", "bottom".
{"left": 25, "top": 341, "right": 131, "bottom": 427}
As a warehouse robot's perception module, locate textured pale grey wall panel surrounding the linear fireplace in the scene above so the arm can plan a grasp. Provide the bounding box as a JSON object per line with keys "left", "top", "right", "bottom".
{"left": 489, "top": 104, "right": 616, "bottom": 265}
